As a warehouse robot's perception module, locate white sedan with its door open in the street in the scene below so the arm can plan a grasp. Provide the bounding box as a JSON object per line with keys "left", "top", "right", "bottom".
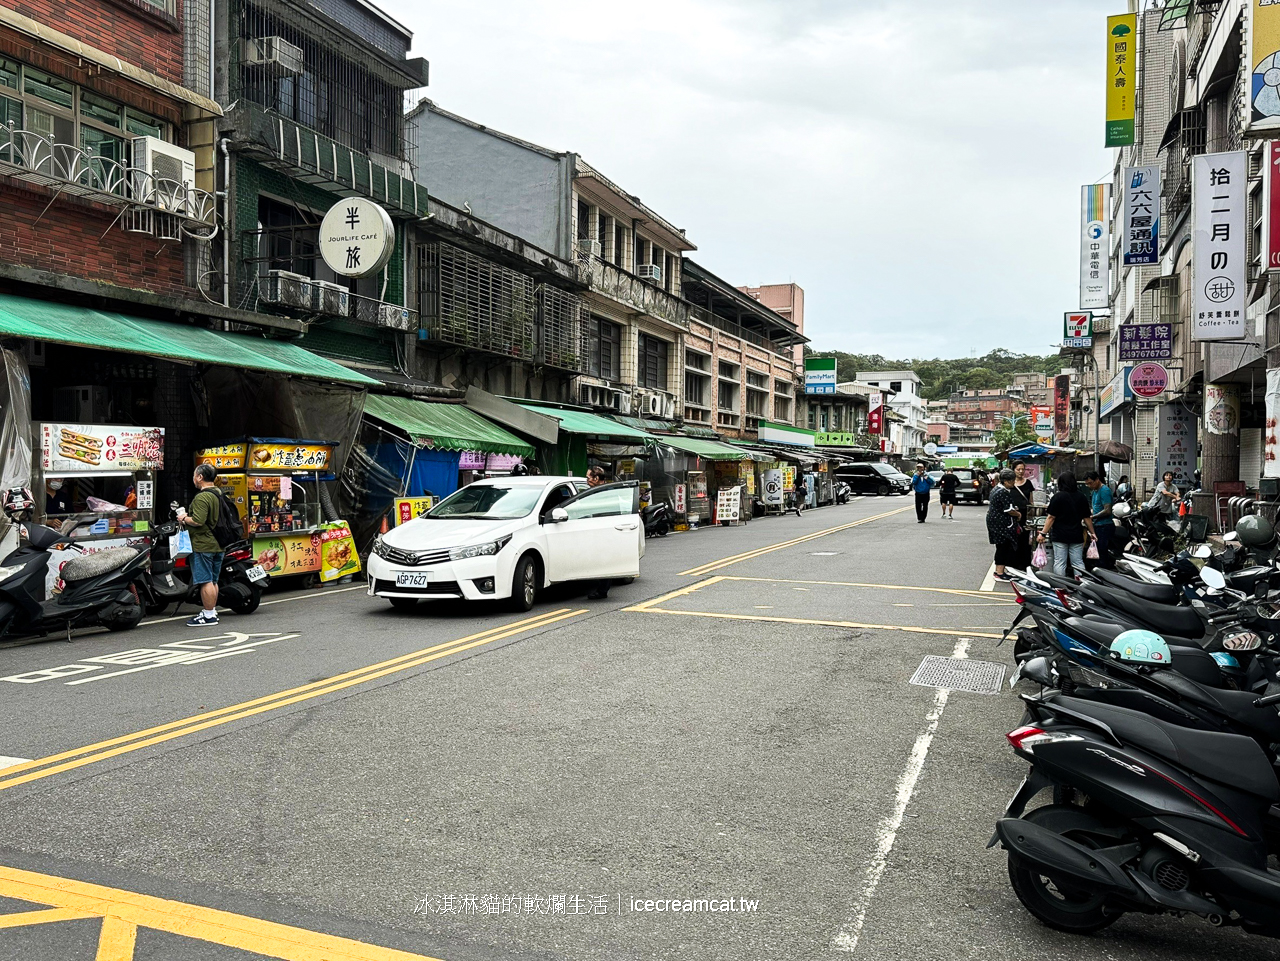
{"left": 369, "top": 476, "right": 644, "bottom": 610}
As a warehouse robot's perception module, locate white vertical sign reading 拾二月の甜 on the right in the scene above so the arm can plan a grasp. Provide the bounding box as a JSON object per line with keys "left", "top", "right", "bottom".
{"left": 1192, "top": 151, "right": 1247, "bottom": 340}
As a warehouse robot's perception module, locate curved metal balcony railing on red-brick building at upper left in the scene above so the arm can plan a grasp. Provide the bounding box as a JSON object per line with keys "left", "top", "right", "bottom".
{"left": 0, "top": 125, "right": 218, "bottom": 241}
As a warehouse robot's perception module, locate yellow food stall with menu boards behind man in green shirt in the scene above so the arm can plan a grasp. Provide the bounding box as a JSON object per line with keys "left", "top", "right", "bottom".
{"left": 196, "top": 438, "right": 360, "bottom": 582}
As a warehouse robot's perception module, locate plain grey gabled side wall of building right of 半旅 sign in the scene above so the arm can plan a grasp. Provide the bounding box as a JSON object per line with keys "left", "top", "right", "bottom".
{"left": 408, "top": 107, "right": 573, "bottom": 260}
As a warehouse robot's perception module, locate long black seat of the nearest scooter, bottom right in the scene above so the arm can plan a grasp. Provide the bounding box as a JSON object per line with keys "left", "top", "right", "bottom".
{"left": 1057, "top": 697, "right": 1280, "bottom": 802}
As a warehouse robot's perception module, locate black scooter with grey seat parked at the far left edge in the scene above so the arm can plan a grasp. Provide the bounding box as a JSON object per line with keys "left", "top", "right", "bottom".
{"left": 0, "top": 488, "right": 150, "bottom": 640}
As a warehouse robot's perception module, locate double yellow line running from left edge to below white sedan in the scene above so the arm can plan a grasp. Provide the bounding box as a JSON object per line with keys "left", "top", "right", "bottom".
{"left": 0, "top": 608, "right": 588, "bottom": 791}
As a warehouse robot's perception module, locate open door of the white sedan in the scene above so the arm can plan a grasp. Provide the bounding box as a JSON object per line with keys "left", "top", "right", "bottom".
{"left": 544, "top": 481, "right": 644, "bottom": 581}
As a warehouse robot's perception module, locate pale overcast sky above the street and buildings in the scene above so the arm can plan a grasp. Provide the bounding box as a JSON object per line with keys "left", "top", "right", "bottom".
{"left": 376, "top": 0, "right": 1126, "bottom": 357}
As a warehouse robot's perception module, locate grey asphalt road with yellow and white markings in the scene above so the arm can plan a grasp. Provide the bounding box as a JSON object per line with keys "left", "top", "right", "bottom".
{"left": 0, "top": 498, "right": 1280, "bottom": 961}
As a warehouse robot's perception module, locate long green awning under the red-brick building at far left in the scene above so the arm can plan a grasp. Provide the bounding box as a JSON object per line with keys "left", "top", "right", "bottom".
{"left": 0, "top": 294, "right": 378, "bottom": 386}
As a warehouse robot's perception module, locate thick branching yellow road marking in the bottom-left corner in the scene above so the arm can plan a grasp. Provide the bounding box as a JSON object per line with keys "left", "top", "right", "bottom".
{"left": 0, "top": 865, "right": 439, "bottom": 961}
